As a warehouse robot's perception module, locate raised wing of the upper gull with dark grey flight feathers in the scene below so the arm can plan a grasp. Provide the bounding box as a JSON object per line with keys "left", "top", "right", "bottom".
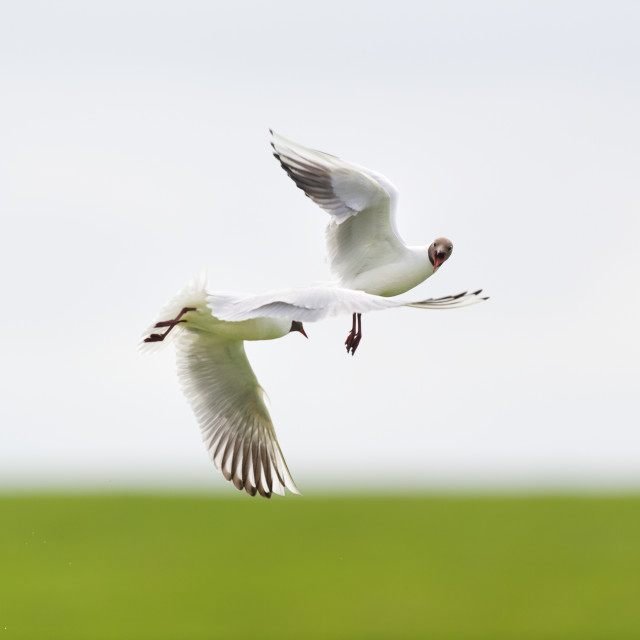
{"left": 271, "top": 132, "right": 407, "bottom": 284}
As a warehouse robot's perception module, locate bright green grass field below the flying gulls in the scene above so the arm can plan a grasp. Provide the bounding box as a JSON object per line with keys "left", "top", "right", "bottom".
{"left": 0, "top": 495, "right": 640, "bottom": 640}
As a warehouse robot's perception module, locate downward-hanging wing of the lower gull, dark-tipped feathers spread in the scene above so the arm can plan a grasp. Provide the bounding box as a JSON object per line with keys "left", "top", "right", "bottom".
{"left": 176, "top": 329, "right": 300, "bottom": 498}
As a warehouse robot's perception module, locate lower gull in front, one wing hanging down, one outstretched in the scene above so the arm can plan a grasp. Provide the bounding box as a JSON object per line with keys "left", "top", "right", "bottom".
{"left": 141, "top": 275, "right": 483, "bottom": 498}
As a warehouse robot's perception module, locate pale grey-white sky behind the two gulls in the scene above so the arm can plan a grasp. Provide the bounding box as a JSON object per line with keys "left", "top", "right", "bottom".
{"left": 0, "top": 1, "right": 640, "bottom": 493}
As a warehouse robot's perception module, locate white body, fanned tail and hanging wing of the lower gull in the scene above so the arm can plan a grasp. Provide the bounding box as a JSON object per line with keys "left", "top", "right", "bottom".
{"left": 141, "top": 276, "right": 299, "bottom": 498}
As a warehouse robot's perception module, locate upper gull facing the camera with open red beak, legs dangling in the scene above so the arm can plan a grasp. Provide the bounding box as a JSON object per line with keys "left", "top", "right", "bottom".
{"left": 271, "top": 131, "right": 453, "bottom": 355}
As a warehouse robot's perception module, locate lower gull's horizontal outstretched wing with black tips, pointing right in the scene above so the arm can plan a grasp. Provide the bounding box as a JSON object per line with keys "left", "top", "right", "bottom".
{"left": 207, "top": 286, "right": 486, "bottom": 322}
